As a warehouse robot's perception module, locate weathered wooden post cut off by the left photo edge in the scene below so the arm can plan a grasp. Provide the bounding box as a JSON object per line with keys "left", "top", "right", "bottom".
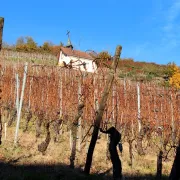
{"left": 0, "top": 17, "right": 4, "bottom": 144}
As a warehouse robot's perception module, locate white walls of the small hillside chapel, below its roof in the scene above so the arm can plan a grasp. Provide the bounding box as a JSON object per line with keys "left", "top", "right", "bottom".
{"left": 58, "top": 51, "right": 97, "bottom": 72}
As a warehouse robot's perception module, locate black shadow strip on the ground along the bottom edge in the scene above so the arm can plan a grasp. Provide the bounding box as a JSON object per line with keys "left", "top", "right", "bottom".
{"left": 0, "top": 162, "right": 168, "bottom": 180}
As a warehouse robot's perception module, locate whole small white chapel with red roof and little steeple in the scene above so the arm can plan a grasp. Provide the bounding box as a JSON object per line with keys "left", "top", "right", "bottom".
{"left": 58, "top": 38, "right": 97, "bottom": 73}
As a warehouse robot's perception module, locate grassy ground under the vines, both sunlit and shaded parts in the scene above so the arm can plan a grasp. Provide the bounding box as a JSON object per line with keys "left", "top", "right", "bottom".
{"left": 0, "top": 122, "right": 172, "bottom": 180}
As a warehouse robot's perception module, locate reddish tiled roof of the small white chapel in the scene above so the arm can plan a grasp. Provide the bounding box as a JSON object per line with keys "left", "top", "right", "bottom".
{"left": 61, "top": 47, "right": 94, "bottom": 60}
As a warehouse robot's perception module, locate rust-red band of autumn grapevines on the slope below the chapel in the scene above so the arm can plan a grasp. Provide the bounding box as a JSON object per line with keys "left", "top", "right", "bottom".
{"left": 1, "top": 57, "right": 180, "bottom": 177}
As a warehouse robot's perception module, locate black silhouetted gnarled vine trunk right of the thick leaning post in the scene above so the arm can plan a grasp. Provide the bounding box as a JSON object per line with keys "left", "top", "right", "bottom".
{"left": 100, "top": 127, "right": 122, "bottom": 180}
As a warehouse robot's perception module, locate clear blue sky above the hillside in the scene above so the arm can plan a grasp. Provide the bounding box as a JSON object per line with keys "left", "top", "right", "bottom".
{"left": 0, "top": 0, "right": 180, "bottom": 65}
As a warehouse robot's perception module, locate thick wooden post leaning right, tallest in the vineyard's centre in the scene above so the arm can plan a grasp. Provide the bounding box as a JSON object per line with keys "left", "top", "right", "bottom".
{"left": 84, "top": 46, "right": 122, "bottom": 174}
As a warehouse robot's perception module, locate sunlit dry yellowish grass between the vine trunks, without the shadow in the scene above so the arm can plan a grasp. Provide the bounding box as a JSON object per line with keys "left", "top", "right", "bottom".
{"left": 0, "top": 124, "right": 172, "bottom": 179}
